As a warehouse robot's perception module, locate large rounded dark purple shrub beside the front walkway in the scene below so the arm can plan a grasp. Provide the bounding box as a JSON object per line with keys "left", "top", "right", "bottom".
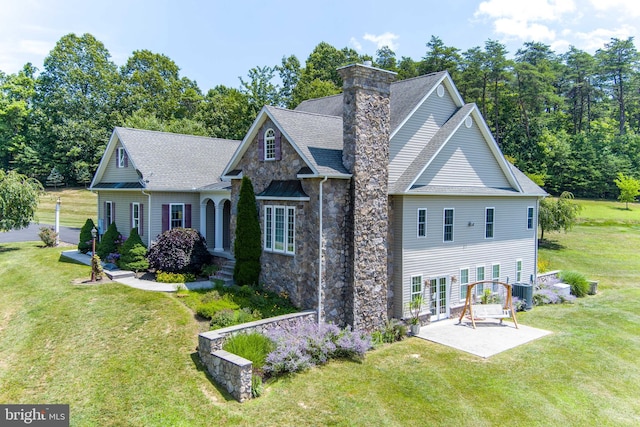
{"left": 147, "top": 228, "right": 211, "bottom": 274}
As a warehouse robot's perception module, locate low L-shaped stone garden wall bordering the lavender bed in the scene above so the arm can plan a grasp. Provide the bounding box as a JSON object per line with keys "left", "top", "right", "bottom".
{"left": 198, "top": 311, "right": 317, "bottom": 402}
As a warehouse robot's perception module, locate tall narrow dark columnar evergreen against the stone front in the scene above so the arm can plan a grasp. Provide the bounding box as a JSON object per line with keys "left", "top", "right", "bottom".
{"left": 233, "top": 176, "right": 262, "bottom": 285}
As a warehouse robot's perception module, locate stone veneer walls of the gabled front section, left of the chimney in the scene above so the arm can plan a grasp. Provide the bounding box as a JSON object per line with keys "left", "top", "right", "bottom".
{"left": 230, "top": 120, "right": 349, "bottom": 326}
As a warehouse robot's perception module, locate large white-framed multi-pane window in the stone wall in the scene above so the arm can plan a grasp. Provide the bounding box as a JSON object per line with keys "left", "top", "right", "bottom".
{"left": 264, "top": 205, "right": 296, "bottom": 254}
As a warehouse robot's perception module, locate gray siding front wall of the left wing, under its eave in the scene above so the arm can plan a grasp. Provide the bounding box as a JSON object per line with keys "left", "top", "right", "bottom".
{"left": 98, "top": 190, "right": 200, "bottom": 246}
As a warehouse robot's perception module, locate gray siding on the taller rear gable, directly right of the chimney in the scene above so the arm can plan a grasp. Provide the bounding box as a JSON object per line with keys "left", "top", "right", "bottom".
{"left": 389, "top": 90, "right": 457, "bottom": 183}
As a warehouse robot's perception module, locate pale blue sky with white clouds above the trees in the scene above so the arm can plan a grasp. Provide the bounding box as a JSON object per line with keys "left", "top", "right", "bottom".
{"left": 0, "top": 0, "right": 640, "bottom": 92}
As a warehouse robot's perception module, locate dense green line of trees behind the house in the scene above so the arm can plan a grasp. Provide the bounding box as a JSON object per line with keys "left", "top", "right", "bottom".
{"left": 0, "top": 34, "right": 640, "bottom": 199}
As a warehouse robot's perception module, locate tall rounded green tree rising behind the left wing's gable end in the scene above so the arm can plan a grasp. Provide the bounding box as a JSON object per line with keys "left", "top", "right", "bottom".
{"left": 36, "top": 34, "right": 119, "bottom": 182}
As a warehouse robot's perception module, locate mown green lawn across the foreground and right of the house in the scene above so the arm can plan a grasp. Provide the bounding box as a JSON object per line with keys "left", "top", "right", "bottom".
{"left": 0, "top": 199, "right": 640, "bottom": 426}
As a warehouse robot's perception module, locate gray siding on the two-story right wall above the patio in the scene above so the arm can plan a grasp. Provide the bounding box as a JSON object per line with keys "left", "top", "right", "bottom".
{"left": 395, "top": 197, "right": 537, "bottom": 316}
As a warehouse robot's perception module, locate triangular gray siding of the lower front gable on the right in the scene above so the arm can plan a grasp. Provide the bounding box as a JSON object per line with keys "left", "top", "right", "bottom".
{"left": 416, "top": 123, "right": 511, "bottom": 188}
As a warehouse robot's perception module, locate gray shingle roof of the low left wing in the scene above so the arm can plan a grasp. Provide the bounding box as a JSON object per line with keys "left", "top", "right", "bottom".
{"left": 115, "top": 127, "right": 240, "bottom": 191}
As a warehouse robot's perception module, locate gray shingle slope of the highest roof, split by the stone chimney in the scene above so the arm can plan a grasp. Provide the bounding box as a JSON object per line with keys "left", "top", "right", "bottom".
{"left": 295, "top": 71, "right": 447, "bottom": 132}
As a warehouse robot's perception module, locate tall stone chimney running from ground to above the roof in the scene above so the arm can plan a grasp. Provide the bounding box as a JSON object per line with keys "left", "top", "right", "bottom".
{"left": 338, "top": 64, "right": 396, "bottom": 331}
